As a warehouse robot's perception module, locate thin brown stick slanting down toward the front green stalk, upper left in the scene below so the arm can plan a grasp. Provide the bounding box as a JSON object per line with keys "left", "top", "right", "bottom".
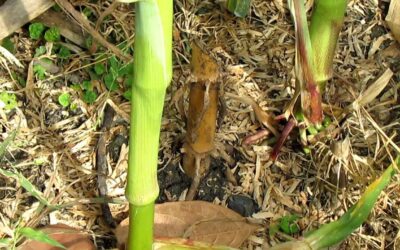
{"left": 55, "top": 0, "right": 132, "bottom": 62}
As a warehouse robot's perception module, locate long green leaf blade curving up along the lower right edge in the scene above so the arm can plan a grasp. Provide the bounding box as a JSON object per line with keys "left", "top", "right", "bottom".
{"left": 271, "top": 156, "right": 400, "bottom": 250}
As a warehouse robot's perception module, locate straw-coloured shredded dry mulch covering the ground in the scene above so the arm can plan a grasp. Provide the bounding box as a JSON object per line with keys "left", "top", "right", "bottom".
{"left": 0, "top": 0, "right": 400, "bottom": 249}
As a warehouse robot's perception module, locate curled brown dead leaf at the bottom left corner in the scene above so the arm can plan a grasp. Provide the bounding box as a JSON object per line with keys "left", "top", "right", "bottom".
{"left": 18, "top": 224, "right": 96, "bottom": 250}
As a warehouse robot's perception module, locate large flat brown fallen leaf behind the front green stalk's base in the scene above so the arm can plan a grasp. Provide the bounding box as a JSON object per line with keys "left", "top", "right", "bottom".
{"left": 115, "top": 201, "right": 258, "bottom": 248}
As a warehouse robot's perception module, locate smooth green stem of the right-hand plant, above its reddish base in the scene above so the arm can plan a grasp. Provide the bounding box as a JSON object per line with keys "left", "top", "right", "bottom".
{"left": 309, "top": 0, "right": 347, "bottom": 89}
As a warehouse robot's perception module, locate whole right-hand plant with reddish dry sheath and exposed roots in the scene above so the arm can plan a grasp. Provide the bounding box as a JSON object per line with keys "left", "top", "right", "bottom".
{"left": 271, "top": 0, "right": 347, "bottom": 160}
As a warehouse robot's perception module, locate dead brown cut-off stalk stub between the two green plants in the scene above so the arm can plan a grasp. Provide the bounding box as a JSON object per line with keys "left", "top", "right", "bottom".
{"left": 183, "top": 44, "right": 219, "bottom": 200}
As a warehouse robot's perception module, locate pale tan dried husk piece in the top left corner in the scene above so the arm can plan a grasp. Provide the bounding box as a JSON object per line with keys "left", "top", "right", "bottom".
{"left": 0, "top": 0, "right": 54, "bottom": 40}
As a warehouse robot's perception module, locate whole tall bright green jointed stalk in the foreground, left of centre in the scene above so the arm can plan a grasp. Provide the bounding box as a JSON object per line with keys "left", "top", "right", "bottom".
{"left": 124, "top": 0, "right": 173, "bottom": 250}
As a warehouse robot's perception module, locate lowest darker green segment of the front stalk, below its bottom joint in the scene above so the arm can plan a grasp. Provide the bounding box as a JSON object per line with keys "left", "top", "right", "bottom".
{"left": 127, "top": 203, "right": 154, "bottom": 250}
